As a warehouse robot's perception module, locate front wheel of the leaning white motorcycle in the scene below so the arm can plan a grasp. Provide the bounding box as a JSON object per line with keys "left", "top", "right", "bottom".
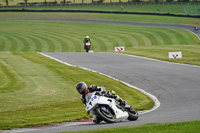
{"left": 95, "top": 106, "right": 116, "bottom": 123}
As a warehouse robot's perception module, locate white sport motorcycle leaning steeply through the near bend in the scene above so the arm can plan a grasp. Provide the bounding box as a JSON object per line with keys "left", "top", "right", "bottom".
{"left": 85, "top": 92, "right": 138, "bottom": 123}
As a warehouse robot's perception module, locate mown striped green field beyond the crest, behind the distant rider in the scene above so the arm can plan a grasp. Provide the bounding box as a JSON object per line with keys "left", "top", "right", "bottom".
{"left": 0, "top": 17, "right": 200, "bottom": 65}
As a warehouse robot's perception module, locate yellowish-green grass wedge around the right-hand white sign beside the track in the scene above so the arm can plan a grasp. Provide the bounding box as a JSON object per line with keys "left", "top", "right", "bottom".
{"left": 123, "top": 45, "right": 200, "bottom": 65}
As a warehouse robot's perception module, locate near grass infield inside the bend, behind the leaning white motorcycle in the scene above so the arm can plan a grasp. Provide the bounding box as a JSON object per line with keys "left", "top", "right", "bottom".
{"left": 0, "top": 52, "right": 153, "bottom": 129}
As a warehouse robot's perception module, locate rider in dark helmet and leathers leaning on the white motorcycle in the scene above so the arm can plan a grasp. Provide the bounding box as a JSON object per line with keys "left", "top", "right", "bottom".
{"left": 76, "top": 82, "right": 126, "bottom": 123}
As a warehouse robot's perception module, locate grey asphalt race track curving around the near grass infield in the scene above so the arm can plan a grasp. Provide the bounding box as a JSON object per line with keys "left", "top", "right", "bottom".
{"left": 1, "top": 19, "right": 200, "bottom": 133}
